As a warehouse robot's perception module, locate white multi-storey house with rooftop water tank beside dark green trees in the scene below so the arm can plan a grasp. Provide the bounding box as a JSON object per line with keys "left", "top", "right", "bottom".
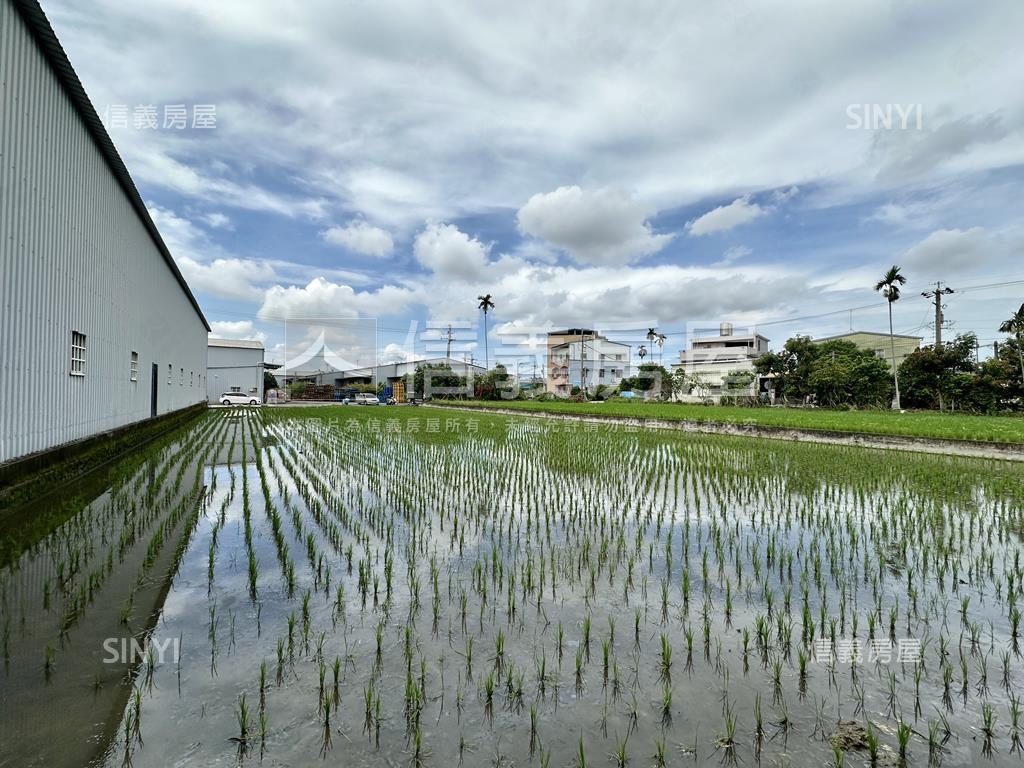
{"left": 672, "top": 323, "right": 769, "bottom": 402}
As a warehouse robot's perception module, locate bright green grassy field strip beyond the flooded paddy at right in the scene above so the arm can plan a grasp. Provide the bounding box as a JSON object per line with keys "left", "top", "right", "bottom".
{"left": 450, "top": 400, "right": 1024, "bottom": 444}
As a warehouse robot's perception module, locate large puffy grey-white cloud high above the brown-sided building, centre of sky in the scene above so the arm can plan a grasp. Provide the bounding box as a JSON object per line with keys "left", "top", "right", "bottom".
{"left": 516, "top": 186, "right": 672, "bottom": 264}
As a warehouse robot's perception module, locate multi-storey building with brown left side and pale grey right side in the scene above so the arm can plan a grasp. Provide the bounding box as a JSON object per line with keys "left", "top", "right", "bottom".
{"left": 547, "top": 329, "right": 631, "bottom": 397}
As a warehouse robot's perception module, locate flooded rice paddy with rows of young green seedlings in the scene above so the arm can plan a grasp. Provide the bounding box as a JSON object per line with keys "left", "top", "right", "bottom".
{"left": 0, "top": 407, "right": 1024, "bottom": 768}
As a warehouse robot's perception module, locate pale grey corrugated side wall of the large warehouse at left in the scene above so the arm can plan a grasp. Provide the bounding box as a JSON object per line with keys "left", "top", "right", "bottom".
{"left": 0, "top": 0, "right": 207, "bottom": 462}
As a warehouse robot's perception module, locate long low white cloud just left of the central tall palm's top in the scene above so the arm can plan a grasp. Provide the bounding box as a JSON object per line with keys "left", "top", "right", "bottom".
{"left": 257, "top": 278, "right": 416, "bottom": 319}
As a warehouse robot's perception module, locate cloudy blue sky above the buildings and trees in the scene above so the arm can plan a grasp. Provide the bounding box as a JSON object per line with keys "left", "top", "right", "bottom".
{"left": 43, "top": 0, "right": 1024, "bottom": 370}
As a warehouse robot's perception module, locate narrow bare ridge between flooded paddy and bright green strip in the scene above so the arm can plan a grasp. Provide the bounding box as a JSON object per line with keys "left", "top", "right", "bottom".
{"left": 424, "top": 403, "right": 1024, "bottom": 462}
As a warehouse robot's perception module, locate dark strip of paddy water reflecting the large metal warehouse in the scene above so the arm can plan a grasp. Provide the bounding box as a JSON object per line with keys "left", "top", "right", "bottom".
{"left": 0, "top": 411, "right": 241, "bottom": 766}
